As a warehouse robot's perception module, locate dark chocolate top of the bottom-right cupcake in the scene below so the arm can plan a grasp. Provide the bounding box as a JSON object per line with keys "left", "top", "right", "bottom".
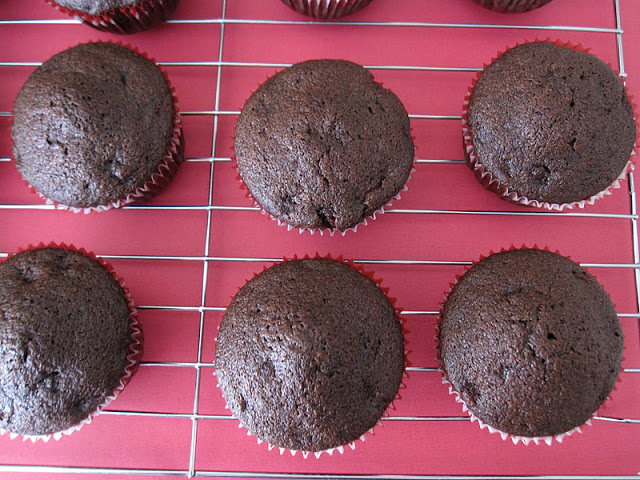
{"left": 439, "top": 249, "right": 623, "bottom": 437}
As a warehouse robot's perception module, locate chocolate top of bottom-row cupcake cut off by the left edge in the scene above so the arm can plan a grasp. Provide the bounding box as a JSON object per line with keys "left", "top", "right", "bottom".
{"left": 0, "top": 248, "right": 133, "bottom": 435}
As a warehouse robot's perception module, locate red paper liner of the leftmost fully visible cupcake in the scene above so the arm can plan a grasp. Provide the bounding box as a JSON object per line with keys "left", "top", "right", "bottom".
{"left": 11, "top": 41, "right": 184, "bottom": 214}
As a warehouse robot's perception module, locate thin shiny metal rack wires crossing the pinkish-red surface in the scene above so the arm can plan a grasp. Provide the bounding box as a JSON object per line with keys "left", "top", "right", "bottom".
{"left": 0, "top": 0, "right": 640, "bottom": 480}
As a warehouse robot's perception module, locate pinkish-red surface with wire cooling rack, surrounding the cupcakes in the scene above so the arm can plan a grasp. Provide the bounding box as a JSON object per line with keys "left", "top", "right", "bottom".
{"left": 0, "top": 0, "right": 640, "bottom": 479}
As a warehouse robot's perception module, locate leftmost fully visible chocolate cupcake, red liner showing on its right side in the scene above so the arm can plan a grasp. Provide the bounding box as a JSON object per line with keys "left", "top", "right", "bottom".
{"left": 12, "top": 42, "right": 183, "bottom": 210}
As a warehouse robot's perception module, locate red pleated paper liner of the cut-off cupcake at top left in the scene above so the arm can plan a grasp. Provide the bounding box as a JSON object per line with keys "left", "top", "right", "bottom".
{"left": 44, "top": 0, "right": 179, "bottom": 34}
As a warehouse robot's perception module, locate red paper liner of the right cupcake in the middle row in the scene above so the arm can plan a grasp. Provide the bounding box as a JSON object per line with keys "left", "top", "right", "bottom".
{"left": 462, "top": 38, "right": 640, "bottom": 212}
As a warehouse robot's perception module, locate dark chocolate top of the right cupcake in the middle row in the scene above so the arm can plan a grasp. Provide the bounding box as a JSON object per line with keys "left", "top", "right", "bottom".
{"left": 468, "top": 42, "right": 636, "bottom": 204}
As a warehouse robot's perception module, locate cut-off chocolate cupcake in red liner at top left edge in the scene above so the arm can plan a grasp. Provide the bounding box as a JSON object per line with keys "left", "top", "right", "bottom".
{"left": 45, "top": 0, "right": 179, "bottom": 34}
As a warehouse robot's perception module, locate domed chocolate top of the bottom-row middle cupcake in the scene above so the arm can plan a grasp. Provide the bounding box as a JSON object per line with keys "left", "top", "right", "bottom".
{"left": 216, "top": 258, "right": 404, "bottom": 452}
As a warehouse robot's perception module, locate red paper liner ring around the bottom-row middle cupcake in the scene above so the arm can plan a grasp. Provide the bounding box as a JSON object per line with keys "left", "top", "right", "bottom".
{"left": 214, "top": 253, "right": 409, "bottom": 459}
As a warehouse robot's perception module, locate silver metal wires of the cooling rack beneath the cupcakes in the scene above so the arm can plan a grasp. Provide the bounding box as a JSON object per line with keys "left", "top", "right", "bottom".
{"left": 0, "top": 0, "right": 640, "bottom": 479}
